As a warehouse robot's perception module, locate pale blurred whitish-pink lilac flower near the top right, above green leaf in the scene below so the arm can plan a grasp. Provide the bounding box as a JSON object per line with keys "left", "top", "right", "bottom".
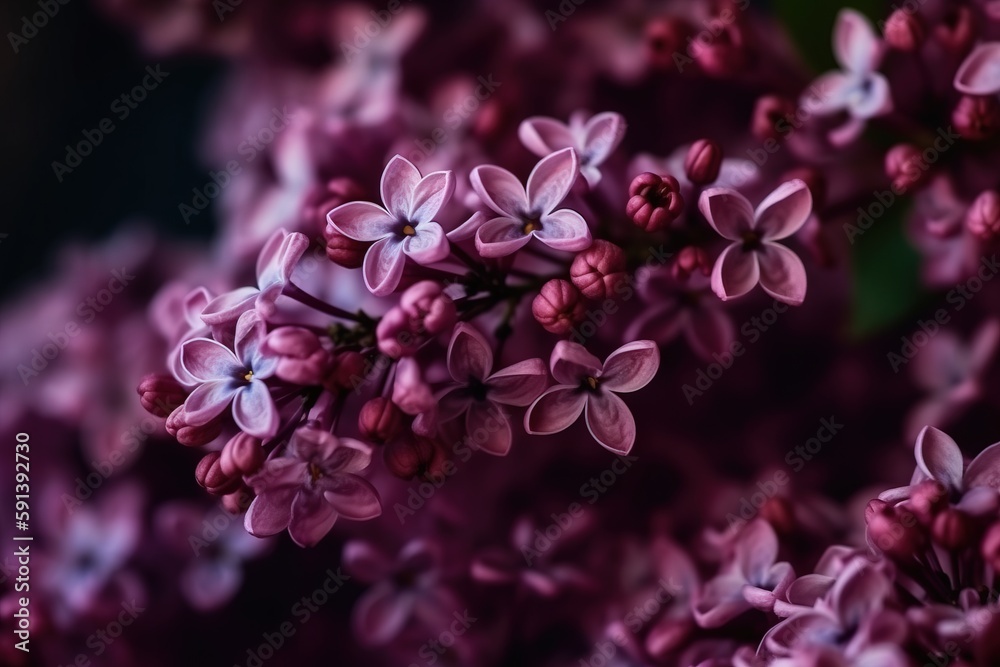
{"left": 802, "top": 9, "right": 892, "bottom": 146}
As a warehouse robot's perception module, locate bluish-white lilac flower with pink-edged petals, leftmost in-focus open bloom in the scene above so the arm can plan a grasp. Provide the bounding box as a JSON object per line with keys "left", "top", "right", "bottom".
{"left": 181, "top": 311, "right": 279, "bottom": 440}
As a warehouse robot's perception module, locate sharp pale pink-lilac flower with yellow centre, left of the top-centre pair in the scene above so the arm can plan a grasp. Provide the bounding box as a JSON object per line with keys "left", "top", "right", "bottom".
{"left": 327, "top": 155, "right": 455, "bottom": 296}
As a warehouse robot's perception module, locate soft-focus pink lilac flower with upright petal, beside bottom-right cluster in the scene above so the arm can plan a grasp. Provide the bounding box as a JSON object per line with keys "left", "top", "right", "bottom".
{"left": 693, "top": 519, "right": 795, "bottom": 628}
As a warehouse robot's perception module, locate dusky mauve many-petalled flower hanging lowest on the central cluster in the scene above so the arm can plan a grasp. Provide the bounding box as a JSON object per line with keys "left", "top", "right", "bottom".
{"left": 244, "top": 426, "right": 382, "bottom": 547}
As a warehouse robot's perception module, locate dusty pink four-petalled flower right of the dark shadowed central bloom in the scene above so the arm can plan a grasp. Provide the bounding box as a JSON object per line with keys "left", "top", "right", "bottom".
{"left": 524, "top": 340, "right": 660, "bottom": 454}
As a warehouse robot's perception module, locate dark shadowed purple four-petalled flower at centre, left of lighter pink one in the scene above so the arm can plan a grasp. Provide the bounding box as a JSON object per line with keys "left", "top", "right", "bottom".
{"left": 424, "top": 322, "right": 549, "bottom": 456}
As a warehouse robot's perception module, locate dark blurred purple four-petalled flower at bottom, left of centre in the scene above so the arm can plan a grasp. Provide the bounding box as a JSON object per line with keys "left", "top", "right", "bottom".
{"left": 343, "top": 540, "right": 459, "bottom": 645}
